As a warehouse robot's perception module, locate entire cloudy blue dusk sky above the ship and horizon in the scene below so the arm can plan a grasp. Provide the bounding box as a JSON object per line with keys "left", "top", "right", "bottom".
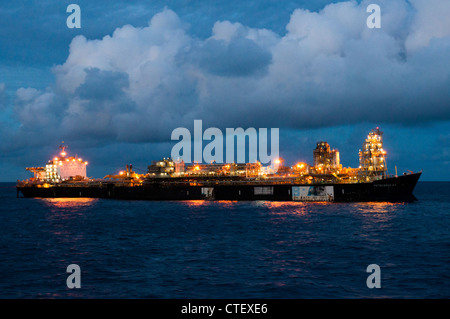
{"left": 0, "top": 0, "right": 450, "bottom": 182}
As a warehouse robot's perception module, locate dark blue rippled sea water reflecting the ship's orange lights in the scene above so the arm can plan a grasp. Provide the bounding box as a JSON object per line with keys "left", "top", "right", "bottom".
{"left": 0, "top": 182, "right": 450, "bottom": 299}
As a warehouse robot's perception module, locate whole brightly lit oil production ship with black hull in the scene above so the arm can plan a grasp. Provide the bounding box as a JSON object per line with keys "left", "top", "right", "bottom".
{"left": 16, "top": 128, "right": 421, "bottom": 202}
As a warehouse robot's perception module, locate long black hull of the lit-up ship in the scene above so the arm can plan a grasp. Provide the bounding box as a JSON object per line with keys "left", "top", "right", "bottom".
{"left": 17, "top": 173, "right": 421, "bottom": 202}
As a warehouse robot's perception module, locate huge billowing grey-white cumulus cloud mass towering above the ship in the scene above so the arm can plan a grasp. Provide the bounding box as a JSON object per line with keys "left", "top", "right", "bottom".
{"left": 6, "top": 0, "right": 450, "bottom": 149}
